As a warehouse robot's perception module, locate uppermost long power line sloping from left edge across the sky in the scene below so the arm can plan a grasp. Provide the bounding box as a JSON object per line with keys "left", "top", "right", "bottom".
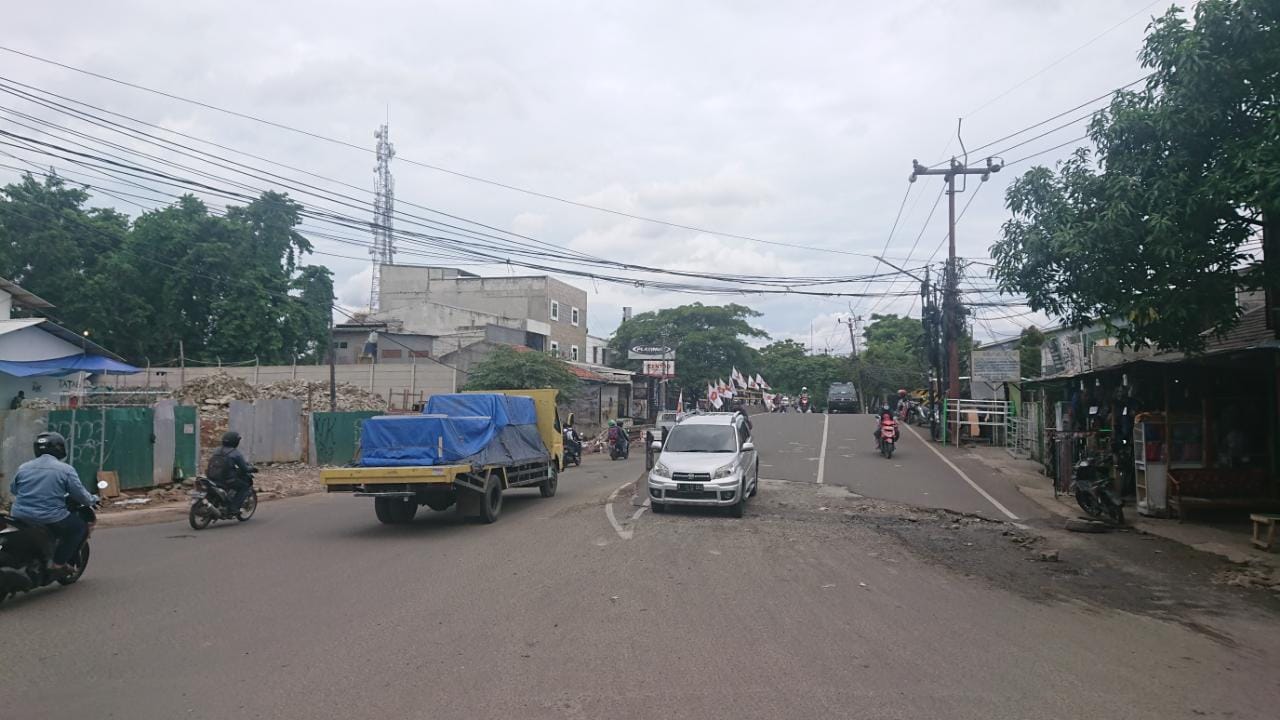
{"left": 0, "top": 45, "right": 901, "bottom": 258}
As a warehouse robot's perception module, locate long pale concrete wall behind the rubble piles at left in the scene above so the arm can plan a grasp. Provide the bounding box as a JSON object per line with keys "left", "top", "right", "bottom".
{"left": 109, "top": 357, "right": 454, "bottom": 397}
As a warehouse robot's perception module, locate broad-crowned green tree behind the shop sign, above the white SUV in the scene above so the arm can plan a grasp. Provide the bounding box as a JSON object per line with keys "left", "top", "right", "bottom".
{"left": 609, "top": 302, "right": 769, "bottom": 397}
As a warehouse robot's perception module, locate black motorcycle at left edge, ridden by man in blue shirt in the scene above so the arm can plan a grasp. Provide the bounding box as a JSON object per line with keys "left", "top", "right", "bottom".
{"left": 0, "top": 482, "right": 108, "bottom": 602}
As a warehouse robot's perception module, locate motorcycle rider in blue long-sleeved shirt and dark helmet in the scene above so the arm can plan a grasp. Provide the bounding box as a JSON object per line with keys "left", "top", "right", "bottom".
{"left": 9, "top": 432, "right": 97, "bottom": 575}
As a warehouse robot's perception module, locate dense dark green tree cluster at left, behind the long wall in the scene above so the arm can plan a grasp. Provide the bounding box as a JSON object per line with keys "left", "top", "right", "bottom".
{"left": 0, "top": 176, "right": 333, "bottom": 364}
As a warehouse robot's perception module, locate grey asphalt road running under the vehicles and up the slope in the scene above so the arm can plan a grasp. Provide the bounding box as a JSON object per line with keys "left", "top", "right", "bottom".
{"left": 0, "top": 415, "right": 1280, "bottom": 720}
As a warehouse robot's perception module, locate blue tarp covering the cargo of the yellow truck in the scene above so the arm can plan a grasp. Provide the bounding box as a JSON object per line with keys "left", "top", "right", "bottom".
{"left": 360, "top": 393, "right": 550, "bottom": 468}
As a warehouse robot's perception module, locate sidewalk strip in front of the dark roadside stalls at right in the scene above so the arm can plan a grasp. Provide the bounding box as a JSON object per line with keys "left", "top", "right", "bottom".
{"left": 965, "top": 447, "right": 1280, "bottom": 569}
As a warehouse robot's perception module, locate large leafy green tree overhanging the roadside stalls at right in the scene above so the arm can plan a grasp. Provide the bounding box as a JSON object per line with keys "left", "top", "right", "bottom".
{"left": 991, "top": 0, "right": 1280, "bottom": 351}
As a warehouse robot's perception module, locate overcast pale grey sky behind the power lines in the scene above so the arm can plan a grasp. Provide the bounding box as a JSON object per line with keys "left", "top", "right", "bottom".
{"left": 0, "top": 0, "right": 1167, "bottom": 352}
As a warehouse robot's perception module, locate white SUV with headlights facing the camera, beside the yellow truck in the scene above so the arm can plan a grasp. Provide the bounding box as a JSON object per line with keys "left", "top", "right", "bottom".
{"left": 649, "top": 413, "right": 760, "bottom": 518}
